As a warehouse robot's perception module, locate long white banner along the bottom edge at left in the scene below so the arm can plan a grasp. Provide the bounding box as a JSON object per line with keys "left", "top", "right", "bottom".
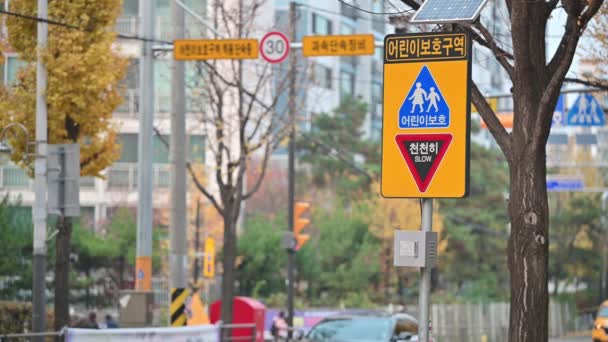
{"left": 65, "top": 325, "right": 220, "bottom": 342}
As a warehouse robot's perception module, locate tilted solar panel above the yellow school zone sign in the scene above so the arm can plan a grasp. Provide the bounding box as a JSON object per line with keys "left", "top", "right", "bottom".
{"left": 411, "top": 0, "right": 488, "bottom": 24}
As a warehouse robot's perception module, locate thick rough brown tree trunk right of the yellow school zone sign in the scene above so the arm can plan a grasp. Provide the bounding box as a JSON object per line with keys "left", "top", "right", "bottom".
{"left": 508, "top": 150, "right": 549, "bottom": 342}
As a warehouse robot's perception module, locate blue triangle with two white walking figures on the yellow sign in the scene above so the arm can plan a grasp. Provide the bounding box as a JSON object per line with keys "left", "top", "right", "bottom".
{"left": 399, "top": 65, "right": 450, "bottom": 128}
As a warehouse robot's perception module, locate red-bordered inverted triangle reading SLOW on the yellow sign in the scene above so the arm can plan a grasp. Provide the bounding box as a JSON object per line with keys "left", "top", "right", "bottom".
{"left": 395, "top": 134, "right": 452, "bottom": 192}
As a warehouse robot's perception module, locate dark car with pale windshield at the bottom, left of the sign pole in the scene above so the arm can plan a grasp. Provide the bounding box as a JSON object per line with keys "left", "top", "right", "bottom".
{"left": 301, "top": 313, "right": 418, "bottom": 342}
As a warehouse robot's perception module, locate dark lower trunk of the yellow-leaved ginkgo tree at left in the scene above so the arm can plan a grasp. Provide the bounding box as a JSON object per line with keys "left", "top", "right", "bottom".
{"left": 55, "top": 216, "right": 72, "bottom": 331}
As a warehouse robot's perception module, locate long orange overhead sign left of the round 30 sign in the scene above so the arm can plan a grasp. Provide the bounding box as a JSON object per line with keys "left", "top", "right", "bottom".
{"left": 173, "top": 39, "right": 259, "bottom": 61}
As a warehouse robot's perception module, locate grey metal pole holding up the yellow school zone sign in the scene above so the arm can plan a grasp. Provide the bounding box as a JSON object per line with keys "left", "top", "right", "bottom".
{"left": 418, "top": 198, "right": 433, "bottom": 342}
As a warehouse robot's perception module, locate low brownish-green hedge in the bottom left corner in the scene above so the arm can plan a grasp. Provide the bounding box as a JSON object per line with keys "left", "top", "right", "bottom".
{"left": 0, "top": 301, "right": 54, "bottom": 334}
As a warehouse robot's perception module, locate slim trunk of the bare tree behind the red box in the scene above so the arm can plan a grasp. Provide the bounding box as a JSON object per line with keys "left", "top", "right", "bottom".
{"left": 221, "top": 210, "right": 236, "bottom": 341}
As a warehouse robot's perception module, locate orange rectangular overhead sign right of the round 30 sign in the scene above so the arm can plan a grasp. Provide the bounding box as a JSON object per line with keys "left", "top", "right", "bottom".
{"left": 302, "top": 34, "right": 375, "bottom": 57}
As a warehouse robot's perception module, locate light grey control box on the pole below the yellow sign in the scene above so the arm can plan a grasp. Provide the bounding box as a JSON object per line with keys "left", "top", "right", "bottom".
{"left": 393, "top": 230, "right": 437, "bottom": 267}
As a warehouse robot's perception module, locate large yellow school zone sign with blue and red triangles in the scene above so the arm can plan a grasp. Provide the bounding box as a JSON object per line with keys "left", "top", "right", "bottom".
{"left": 381, "top": 33, "right": 472, "bottom": 198}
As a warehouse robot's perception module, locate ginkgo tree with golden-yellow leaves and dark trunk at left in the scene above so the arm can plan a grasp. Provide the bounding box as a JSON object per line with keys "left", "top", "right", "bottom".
{"left": 0, "top": 0, "right": 127, "bottom": 329}
